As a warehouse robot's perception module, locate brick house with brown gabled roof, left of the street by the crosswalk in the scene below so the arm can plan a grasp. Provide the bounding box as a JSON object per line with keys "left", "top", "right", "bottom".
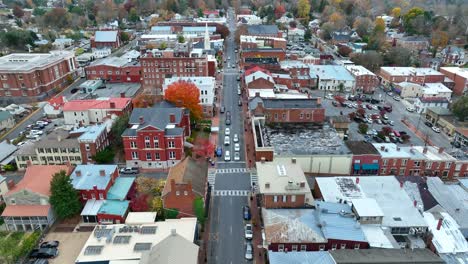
{"left": 161, "top": 157, "right": 208, "bottom": 217}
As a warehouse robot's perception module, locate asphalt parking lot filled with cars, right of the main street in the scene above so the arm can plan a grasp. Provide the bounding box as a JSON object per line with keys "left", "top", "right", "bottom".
{"left": 312, "top": 86, "right": 452, "bottom": 149}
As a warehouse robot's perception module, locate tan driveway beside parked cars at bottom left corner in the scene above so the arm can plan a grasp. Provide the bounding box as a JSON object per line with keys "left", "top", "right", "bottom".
{"left": 44, "top": 232, "right": 91, "bottom": 264}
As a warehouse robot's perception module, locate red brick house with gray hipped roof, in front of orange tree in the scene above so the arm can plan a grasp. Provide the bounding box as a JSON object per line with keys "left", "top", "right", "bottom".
{"left": 122, "top": 101, "right": 191, "bottom": 169}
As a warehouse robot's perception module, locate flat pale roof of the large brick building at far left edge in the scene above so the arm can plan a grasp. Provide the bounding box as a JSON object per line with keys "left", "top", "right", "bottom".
{"left": 0, "top": 51, "right": 74, "bottom": 73}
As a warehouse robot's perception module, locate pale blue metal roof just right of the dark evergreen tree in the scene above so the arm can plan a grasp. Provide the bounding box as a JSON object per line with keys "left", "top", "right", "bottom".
{"left": 70, "top": 164, "right": 117, "bottom": 190}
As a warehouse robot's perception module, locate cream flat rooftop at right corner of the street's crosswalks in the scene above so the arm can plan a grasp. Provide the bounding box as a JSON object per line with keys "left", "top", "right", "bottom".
{"left": 256, "top": 161, "right": 313, "bottom": 204}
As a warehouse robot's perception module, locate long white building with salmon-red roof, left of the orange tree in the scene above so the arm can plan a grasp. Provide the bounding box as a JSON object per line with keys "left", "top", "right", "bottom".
{"left": 63, "top": 97, "right": 132, "bottom": 126}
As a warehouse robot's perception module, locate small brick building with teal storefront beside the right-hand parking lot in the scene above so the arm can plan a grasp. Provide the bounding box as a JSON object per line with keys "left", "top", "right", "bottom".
{"left": 345, "top": 141, "right": 381, "bottom": 175}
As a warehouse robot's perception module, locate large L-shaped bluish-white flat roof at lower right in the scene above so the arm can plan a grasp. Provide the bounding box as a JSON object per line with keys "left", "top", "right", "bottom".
{"left": 315, "top": 176, "right": 427, "bottom": 227}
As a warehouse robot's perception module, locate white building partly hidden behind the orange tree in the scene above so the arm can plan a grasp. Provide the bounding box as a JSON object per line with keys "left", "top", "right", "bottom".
{"left": 163, "top": 76, "right": 216, "bottom": 117}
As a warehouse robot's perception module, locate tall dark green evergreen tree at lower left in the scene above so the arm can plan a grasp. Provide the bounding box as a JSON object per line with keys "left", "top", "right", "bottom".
{"left": 50, "top": 170, "right": 81, "bottom": 219}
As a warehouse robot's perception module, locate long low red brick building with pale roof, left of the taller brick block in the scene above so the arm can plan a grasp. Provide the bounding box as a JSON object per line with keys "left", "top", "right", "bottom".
{"left": 85, "top": 57, "right": 141, "bottom": 83}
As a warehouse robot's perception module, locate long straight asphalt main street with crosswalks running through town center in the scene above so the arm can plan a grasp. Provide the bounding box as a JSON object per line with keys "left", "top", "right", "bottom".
{"left": 208, "top": 9, "right": 251, "bottom": 264}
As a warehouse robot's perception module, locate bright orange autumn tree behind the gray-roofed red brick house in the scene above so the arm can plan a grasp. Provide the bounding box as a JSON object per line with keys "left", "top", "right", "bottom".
{"left": 164, "top": 81, "right": 202, "bottom": 120}
